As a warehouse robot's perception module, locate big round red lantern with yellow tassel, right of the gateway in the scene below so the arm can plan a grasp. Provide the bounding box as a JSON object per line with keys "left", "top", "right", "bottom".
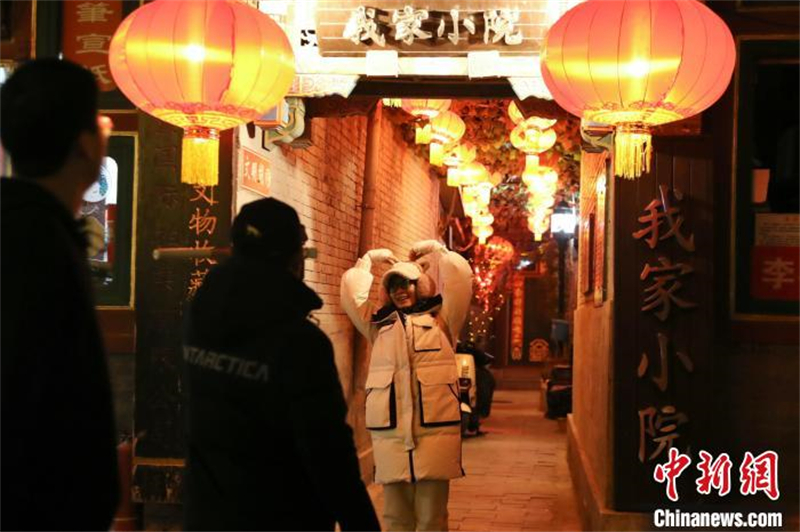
{"left": 541, "top": 0, "right": 736, "bottom": 178}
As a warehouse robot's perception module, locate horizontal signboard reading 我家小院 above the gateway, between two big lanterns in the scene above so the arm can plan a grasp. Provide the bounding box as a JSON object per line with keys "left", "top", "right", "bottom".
{"left": 316, "top": 0, "right": 552, "bottom": 56}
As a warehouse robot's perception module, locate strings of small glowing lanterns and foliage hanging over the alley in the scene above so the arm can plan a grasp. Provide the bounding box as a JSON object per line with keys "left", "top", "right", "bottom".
{"left": 384, "top": 99, "right": 581, "bottom": 251}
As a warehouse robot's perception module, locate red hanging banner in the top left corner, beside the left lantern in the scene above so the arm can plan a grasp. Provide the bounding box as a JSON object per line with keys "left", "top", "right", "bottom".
{"left": 62, "top": 0, "right": 122, "bottom": 92}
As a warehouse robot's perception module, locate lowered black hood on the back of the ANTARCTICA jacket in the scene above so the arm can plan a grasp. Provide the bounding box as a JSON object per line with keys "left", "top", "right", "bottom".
{"left": 189, "top": 255, "right": 322, "bottom": 346}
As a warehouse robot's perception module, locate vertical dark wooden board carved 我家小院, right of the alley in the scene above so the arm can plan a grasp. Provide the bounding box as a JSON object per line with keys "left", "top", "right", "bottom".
{"left": 613, "top": 137, "right": 715, "bottom": 512}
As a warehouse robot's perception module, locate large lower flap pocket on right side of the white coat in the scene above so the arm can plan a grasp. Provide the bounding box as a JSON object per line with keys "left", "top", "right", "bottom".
{"left": 417, "top": 365, "right": 461, "bottom": 427}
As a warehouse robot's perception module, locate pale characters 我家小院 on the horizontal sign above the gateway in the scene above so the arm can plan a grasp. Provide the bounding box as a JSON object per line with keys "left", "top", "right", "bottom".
{"left": 342, "top": 5, "right": 523, "bottom": 47}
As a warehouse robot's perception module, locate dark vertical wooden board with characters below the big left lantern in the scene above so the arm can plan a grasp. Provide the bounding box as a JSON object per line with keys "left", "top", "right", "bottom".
{"left": 133, "top": 114, "right": 233, "bottom": 504}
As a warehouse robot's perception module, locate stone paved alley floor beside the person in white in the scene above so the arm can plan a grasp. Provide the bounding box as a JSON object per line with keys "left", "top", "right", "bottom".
{"left": 370, "top": 390, "right": 581, "bottom": 531}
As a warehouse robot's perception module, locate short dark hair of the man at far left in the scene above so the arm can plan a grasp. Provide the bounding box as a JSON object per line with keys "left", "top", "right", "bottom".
{"left": 0, "top": 59, "right": 98, "bottom": 178}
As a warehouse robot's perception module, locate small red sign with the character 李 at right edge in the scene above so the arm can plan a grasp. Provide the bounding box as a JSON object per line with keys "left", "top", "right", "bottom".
{"left": 750, "top": 246, "right": 800, "bottom": 301}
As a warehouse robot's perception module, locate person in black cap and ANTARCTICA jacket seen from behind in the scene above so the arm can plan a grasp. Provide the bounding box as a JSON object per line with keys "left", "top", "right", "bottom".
{"left": 183, "top": 198, "right": 380, "bottom": 530}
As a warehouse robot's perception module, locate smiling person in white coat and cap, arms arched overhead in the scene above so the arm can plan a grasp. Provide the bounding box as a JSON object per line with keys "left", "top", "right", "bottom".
{"left": 341, "top": 240, "right": 472, "bottom": 531}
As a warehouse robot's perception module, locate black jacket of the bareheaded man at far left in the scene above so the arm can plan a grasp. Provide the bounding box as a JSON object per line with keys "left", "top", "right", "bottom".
{"left": 0, "top": 178, "right": 119, "bottom": 530}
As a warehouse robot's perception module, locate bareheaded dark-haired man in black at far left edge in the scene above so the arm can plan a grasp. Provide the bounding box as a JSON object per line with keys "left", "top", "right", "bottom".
{"left": 0, "top": 59, "right": 119, "bottom": 530}
